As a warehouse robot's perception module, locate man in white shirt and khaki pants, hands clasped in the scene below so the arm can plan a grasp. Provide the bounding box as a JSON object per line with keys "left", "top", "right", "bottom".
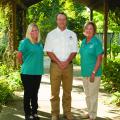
{"left": 44, "top": 13, "right": 77, "bottom": 120}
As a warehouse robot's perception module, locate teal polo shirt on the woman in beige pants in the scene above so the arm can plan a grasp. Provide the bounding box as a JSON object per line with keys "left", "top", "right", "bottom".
{"left": 80, "top": 36, "right": 104, "bottom": 77}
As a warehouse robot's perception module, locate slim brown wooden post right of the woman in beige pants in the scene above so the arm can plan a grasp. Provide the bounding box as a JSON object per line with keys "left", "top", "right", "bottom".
{"left": 103, "top": 0, "right": 109, "bottom": 65}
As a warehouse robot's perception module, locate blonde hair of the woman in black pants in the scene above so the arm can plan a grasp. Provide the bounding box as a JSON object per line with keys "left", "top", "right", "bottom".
{"left": 26, "top": 23, "right": 40, "bottom": 43}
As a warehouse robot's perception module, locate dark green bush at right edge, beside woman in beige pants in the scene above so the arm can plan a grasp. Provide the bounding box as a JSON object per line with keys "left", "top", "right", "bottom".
{"left": 102, "top": 58, "right": 120, "bottom": 93}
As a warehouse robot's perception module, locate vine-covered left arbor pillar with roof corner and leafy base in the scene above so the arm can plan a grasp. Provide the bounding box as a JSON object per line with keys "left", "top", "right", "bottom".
{"left": 0, "top": 0, "right": 41, "bottom": 68}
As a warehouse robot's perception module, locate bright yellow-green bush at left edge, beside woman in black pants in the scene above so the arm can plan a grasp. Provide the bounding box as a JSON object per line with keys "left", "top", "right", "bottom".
{"left": 0, "top": 64, "right": 22, "bottom": 104}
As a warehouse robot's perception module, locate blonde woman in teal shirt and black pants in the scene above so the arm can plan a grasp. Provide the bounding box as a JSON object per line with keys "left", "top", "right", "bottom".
{"left": 18, "top": 23, "right": 43, "bottom": 120}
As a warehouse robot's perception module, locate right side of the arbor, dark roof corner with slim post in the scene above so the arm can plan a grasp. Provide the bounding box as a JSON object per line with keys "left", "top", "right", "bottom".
{"left": 78, "top": 0, "right": 120, "bottom": 64}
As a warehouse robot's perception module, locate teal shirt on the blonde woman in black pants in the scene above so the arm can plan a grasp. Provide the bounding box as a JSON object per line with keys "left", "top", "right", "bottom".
{"left": 18, "top": 38, "right": 43, "bottom": 75}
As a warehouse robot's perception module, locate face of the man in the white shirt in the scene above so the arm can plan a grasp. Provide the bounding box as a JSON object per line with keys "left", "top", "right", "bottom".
{"left": 57, "top": 14, "right": 67, "bottom": 30}
